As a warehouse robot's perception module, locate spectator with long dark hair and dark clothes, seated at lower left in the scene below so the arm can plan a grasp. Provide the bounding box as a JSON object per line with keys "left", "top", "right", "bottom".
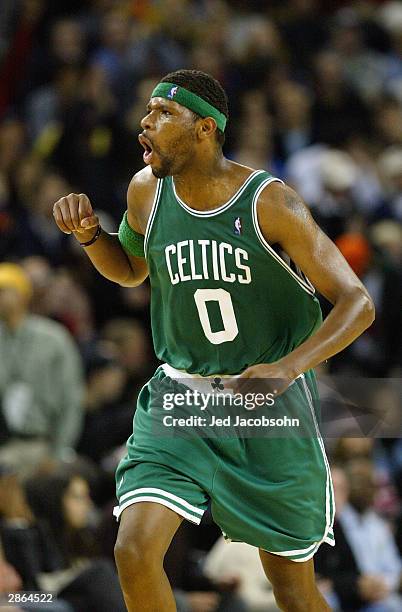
{"left": 27, "top": 469, "right": 126, "bottom": 612}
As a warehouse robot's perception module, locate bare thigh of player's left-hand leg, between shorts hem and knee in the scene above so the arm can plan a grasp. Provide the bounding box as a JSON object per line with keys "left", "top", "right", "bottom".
{"left": 115, "top": 502, "right": 183, "bottom": 559}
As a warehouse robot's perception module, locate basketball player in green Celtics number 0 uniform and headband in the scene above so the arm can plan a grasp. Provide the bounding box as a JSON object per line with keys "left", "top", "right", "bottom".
{"left": 54, "top": 70, "right": 374, "bottom": 612}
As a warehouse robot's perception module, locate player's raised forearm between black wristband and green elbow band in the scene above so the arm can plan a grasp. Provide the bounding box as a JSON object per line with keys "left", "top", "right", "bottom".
{"left": 74, "top": 230, "right": 146, "bottom": 287}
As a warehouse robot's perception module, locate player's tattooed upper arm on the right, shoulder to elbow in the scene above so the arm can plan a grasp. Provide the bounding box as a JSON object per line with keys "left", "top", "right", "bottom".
{"left": 259, "top": 185, "right": 364, "bottom": 304}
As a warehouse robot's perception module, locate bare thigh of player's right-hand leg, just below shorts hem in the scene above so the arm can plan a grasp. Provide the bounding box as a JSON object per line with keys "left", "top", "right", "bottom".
{"left": 260, "top": 549, "right": 315, "bottom": 593}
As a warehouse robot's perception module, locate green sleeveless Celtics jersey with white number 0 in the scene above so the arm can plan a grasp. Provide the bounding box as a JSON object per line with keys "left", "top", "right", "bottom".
{"left": 145, "top": 170, "right": 322, "bottom": 376}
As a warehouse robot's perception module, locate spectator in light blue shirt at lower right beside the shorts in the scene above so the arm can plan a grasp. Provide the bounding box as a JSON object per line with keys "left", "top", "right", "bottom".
{"left": 316, "top": 459, "right": 402, "bottom": 612}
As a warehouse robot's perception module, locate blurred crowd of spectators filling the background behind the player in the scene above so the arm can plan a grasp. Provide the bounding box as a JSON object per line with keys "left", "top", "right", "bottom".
{"left": 0, "top": 0, "right": 402, "bottom": 612}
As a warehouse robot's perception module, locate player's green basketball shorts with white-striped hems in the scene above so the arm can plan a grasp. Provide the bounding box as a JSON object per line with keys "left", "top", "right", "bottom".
{"left": 114, "top": 365, "right": 335, "bottom": 562}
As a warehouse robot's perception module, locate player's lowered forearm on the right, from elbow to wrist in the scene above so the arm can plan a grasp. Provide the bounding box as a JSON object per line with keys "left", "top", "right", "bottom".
{"left": 278, "top": 287, "right": 375, "bottom": 377}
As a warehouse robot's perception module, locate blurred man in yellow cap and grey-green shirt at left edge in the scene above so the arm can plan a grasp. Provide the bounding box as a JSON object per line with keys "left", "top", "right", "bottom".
{"left": 0, "top": 263, "right": 82, "bottom": 477}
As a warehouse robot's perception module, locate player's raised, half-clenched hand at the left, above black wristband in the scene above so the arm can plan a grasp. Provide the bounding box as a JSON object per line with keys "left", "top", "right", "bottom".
{"left": 53, "top": 193, "right": 99, "bottom": 236}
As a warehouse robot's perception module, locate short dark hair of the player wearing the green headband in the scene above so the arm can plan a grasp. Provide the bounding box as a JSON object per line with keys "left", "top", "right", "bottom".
{"left": 160, "top": 70, "right": 229, "bottom": 146}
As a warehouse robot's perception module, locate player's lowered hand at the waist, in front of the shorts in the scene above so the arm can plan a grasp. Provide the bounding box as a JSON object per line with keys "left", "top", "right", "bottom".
{"left": 231, "top": 363, "right": 295, "bottom": 397}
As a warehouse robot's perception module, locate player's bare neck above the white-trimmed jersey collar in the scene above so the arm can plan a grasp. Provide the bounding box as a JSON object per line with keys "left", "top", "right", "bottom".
{"left": 173, "top": 154, "right": 242, "bottom": 210}
